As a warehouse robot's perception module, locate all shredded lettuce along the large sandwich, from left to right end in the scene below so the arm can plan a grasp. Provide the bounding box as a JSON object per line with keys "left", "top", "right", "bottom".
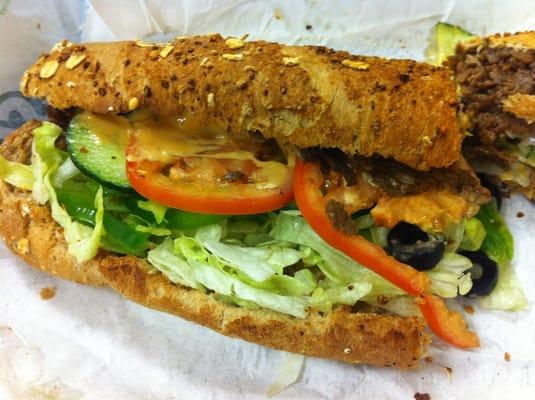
{"left": 0, "top": 123, "right": 527, "bottom": 318}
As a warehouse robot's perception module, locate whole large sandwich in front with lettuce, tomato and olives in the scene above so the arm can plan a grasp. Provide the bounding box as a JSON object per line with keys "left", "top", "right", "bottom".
{"left": 0, "top": 34, "right": 525, "bottom": 369}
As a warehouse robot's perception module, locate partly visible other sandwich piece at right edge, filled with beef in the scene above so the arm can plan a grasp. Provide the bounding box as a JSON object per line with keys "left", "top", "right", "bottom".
{"left": 431, "top": 24, "right": 535, "bottom": 200}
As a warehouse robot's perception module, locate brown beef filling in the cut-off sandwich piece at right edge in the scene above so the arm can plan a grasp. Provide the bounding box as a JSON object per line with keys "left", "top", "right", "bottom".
{"left": 449, "top": 41, "right": 535, "bottom": 198}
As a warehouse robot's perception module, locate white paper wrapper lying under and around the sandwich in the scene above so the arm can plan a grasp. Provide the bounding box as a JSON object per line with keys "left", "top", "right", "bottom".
{"left": 0, "top": 0, "right": 535, "bottom": 400}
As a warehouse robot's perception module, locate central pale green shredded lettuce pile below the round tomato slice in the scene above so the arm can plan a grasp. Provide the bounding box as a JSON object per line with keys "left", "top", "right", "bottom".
{"left": 144, "top": 214, "right": 378, "bottom": 318}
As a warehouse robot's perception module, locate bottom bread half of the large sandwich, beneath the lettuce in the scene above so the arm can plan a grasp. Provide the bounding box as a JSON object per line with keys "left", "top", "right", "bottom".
{"left": 0, "top": 121, "right": 429, "bottom": 369}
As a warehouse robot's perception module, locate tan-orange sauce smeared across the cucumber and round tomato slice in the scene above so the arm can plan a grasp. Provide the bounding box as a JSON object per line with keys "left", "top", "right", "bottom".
{"left": 77, "top": 110, "right": 295, "bottom": 190}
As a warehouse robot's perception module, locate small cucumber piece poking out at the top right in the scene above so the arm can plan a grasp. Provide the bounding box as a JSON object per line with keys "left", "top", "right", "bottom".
{"left": 424, "top": 22, "right": 474, "bottom": 65}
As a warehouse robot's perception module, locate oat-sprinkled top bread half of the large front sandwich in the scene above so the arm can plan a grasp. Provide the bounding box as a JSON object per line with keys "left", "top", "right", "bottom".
{"left": 21, "top": 35, "right": 462, "bottom": 170}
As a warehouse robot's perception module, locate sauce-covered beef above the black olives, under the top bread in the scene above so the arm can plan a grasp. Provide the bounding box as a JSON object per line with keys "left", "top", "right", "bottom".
{"left": 301, "top": 148, "right": 490, "bottom": 234}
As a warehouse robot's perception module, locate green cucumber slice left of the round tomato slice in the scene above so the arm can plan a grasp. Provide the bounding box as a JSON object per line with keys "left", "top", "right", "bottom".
{"left": 67, "top": 112, "right": 131, "bottom": 190}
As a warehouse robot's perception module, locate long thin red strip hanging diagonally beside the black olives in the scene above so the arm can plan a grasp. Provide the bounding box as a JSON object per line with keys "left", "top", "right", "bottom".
{"left": 294, "top": 160, "right": 479, "bottom": 348}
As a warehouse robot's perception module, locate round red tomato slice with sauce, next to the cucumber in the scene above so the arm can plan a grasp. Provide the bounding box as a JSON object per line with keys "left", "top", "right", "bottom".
{"left": 126, "top": 134, "right": 293, "bottom": 215}
